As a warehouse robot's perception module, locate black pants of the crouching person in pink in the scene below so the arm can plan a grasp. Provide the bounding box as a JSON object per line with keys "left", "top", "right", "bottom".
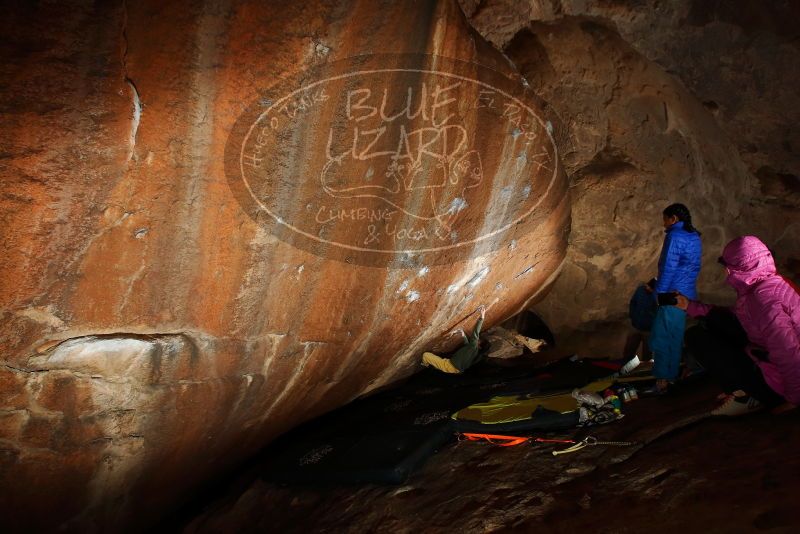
{"left": 685, "top": 308, "right": 786, "bottom": 406}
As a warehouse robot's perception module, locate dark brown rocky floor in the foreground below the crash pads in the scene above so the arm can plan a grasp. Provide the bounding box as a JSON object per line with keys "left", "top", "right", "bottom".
{"left": 181, "top": 372, "right": 800, "bottom": 533}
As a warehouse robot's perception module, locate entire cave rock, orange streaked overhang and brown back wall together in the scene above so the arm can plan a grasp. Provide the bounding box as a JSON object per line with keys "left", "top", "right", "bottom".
{"left": 0, "top": 0, "right": 800, "bottom": 529}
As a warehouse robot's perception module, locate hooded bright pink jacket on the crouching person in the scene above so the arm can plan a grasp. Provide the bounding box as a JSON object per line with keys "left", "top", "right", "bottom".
{"left": 687, "top": 236, "right": 800, "bottom": 405}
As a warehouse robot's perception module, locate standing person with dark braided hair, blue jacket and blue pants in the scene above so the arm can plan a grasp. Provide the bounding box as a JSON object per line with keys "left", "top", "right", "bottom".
{"left": 649, "top": 204, "right": 702, "bottom": 392}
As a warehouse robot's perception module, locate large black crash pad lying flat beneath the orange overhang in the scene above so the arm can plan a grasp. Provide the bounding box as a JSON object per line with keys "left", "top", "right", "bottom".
{"left": 262, "top": 363, "right": 552, "bottom": 484}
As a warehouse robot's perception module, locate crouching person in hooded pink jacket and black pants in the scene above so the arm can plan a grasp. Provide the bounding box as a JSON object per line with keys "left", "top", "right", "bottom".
{"left": 678, "top": 236, "right": 800, "bottom": 415}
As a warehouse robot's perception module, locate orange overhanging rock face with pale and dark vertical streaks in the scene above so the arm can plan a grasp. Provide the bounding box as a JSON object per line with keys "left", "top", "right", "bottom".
{"left": 0, "top": 1, "right": 569, "bottom": 528}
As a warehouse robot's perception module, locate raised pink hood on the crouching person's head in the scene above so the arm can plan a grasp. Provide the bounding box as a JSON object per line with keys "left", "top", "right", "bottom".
{"left": 722, "top": 235, "right": 776, "bottom": 293}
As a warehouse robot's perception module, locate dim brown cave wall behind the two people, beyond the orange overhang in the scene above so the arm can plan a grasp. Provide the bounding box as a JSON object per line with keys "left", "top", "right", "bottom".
{"left": 462, "top": 0, "right": 800, "bottom": 355}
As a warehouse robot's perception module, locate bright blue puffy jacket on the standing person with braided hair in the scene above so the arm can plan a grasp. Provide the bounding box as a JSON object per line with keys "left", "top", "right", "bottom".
{"left": 655, "top": 221, "right": 703, "bottom": 299}
